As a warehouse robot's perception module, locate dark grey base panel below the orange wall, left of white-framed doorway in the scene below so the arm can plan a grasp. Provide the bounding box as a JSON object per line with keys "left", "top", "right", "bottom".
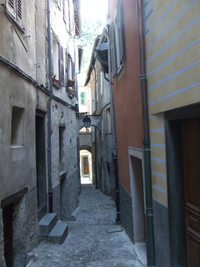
{"left": 119, "top": 183, "right": 134, "bottom": 242}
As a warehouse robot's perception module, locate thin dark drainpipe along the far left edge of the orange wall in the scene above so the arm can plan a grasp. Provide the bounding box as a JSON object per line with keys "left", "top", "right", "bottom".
{"left": 106, "top": 27, "right": 120, "bottom": 223}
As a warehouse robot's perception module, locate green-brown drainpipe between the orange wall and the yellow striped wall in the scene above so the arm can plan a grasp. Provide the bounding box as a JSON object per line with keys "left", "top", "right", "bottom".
{"left": 137, "top": 0, "right": 155, "bottom": 267}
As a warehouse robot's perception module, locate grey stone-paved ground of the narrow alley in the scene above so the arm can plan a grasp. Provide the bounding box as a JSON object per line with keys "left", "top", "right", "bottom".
{"left": 28, "top": 181, "right": 146, "bottom": 267}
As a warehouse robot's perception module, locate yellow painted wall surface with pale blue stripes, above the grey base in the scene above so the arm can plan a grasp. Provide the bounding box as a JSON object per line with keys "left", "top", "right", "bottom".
{"left": 146, "top": 0, "right": 200, "bottom": 206}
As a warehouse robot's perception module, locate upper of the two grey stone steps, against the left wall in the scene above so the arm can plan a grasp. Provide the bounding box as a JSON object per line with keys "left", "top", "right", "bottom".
{"left": 39, "top": 213, "right": 58, "bottom": 236}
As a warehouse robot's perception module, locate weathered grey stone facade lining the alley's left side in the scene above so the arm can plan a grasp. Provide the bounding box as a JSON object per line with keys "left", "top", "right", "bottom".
{"left": 0, "top": 0, "right": 80, "bottom": 266}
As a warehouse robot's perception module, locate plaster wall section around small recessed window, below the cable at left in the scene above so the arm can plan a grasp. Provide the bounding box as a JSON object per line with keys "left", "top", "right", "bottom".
{"left": 0, "top": 64, "right": 36, "bottom": 200}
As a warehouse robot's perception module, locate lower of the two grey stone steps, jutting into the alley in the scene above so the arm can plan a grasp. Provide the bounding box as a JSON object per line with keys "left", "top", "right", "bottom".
{"left": 48, "top": 221, "right": 68, "bottom": 245}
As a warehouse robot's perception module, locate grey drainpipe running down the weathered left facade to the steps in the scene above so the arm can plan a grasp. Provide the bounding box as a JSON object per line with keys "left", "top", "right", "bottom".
{"left": 47, "top": 0, "right": 53, "bottom": 213}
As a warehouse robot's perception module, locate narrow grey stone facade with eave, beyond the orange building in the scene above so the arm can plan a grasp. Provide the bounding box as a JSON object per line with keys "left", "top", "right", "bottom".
{"left": 85, "top": 37, "right": 115, "bottom": 198}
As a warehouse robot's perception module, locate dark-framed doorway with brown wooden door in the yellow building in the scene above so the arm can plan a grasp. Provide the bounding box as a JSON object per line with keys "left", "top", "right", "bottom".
{"left": 165, "top": 104, "right": 200, "bottom": 267}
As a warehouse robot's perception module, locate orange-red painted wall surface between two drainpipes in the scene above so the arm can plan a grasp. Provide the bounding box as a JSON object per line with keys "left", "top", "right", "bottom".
{"left": 109, "top": 0, "right": 143, "bottom": 193}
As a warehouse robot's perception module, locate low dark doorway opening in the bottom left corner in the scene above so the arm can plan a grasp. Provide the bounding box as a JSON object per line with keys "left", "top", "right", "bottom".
{"left": 3, "top": 204, "right": 14, "bottom": 267}
